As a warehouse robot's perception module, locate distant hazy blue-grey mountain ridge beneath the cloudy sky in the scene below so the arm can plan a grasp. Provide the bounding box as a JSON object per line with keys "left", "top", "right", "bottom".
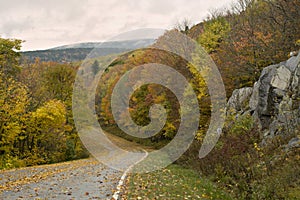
{"left": 21, "top": 39, "right": 156, "bottom": 63}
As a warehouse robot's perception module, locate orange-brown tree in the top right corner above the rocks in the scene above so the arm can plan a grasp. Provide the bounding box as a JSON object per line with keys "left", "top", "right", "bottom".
{"left": 224, "top": 0, "right": 300, "bottom": 74}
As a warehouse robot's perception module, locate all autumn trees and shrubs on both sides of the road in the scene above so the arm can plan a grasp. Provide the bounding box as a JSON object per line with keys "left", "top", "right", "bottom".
{"left": 0, "top": 0, "right": 300, "bottom": 199}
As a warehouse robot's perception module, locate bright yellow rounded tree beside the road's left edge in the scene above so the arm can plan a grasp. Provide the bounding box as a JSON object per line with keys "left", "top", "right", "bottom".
{"left": 26, "top": 100, "right": 66, "bottom": 164}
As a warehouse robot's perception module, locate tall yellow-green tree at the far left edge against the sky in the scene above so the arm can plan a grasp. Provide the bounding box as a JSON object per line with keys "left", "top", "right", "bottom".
{"left": 0, "top": 38, "right": 29, "bottom": 158}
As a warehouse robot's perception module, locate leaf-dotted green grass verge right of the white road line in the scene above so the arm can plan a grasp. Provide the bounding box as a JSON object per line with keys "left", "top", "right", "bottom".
{"left": 124, "top": 164, "right": 232, "bottom": 200}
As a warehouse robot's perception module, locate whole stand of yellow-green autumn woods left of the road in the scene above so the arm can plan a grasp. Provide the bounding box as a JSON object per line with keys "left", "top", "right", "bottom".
{"left": 0, "top": 38, "right": 88, "bottom": 168}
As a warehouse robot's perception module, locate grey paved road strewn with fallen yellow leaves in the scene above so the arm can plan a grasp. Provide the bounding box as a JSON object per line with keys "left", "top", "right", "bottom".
{"left": 0, "top": 136, "right": 148, "bottom": 200}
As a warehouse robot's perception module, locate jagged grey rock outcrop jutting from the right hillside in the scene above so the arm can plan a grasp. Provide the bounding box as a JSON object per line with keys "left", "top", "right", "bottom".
{"left": 227, "top": 50, "right": 300, "bottom": 143}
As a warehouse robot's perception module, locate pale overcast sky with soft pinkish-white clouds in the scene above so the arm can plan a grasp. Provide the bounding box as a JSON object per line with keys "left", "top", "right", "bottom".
{"left": 0, "top": 0, "right": 233, "bottom": 50}
